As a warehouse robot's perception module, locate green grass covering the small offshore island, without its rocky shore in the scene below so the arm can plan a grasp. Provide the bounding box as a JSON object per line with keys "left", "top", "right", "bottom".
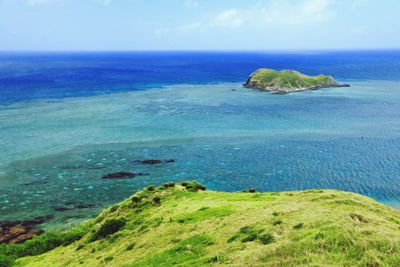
{"left": 248, "top": 69, "right": 336, "bottom": 90}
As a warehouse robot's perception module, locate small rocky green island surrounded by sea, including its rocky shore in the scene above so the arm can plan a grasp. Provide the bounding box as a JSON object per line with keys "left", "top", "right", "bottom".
{"left": 243, "top": 68, "right": 350, "bottom": 94}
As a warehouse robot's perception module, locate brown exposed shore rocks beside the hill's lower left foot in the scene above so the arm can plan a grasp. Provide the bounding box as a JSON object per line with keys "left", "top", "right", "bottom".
{"left": 0, "top": 215, "right": 54, "bottom": 244}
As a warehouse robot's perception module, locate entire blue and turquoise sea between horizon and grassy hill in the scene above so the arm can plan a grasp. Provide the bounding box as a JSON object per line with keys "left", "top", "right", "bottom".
{"left": 0, "top": 50, "right": 400, "bottom": 229}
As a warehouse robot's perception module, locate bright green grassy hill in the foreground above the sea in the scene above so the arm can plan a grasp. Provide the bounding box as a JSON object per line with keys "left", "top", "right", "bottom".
{"left": 0, "top": 182, "right": 400, "bottom": 266}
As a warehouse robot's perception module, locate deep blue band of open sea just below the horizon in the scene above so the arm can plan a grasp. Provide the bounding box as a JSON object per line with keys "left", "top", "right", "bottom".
{"left": 0, "top": 50, "right": 400, "bottom": 104}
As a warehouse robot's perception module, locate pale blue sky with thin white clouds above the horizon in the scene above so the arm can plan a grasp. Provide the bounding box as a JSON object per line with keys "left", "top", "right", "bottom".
{"left": 0, "top": 0, "right": 400, "bottom": 51}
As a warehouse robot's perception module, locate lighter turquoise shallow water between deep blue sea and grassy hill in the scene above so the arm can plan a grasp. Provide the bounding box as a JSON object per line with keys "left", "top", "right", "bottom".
{"left": 0, "top": 81, "right": 400, "bottom": 228}
